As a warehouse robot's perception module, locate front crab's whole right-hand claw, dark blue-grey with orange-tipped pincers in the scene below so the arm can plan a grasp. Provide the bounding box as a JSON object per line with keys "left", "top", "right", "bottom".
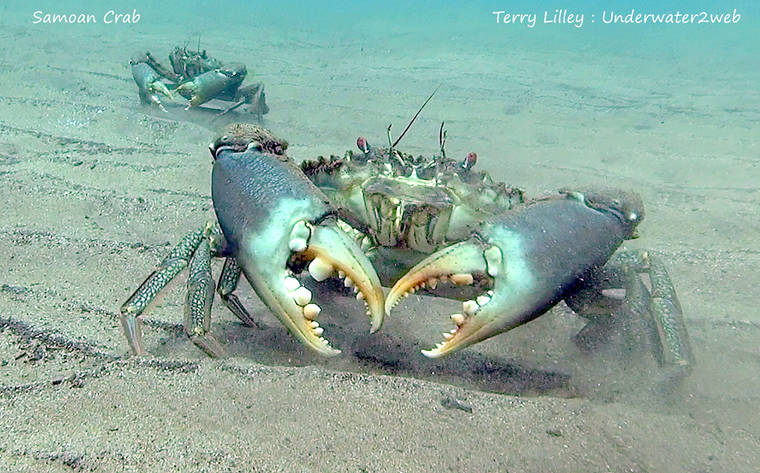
{"left": 386, "top": 192, "right": 643, "bottom": 358}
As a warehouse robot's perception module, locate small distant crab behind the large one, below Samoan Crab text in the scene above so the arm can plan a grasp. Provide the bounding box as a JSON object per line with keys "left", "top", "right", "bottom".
{"left": 129, "top": 47, "right": 269, "bottom": 117}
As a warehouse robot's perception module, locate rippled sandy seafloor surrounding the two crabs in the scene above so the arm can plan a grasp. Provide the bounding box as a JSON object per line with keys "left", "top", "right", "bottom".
{"left": 0, "top": 2, "right": 760, "bottom": 472}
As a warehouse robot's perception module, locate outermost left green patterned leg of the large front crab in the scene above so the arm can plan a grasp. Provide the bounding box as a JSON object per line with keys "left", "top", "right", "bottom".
{"left": 121, "top": 228, "right": 206, "bottom": 355}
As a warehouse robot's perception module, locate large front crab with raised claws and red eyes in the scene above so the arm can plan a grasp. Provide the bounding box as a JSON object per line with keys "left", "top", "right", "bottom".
{"left": 121, "top": 124, "right": 691, "bottom": 376}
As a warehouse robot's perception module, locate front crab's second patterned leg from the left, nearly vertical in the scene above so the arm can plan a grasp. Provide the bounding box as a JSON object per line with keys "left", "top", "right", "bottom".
{"left": 185, "top": 238, "right": 224, "bottom": 357}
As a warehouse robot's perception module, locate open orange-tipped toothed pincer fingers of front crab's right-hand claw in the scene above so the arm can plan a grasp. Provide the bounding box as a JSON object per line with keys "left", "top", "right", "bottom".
{"left": 385, "top": 238, "right": 522, "bottom": 358}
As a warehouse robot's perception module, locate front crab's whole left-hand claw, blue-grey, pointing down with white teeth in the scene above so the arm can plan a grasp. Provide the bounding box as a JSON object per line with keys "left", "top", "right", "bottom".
{"left": 212, "top": 127, "right": 384, "bottom": 356}
